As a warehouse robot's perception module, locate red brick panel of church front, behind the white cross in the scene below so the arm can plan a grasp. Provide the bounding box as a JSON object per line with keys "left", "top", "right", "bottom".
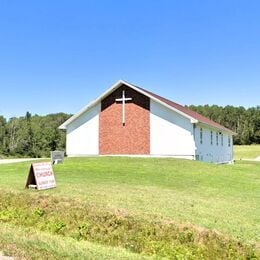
{"left": 99, "top": 86, "right": 150, "bottom": 154}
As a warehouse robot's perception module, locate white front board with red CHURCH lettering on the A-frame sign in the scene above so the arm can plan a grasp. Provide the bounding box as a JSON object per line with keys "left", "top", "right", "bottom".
{"left": 32, "top": 162, "right": 56, "bottom": 190}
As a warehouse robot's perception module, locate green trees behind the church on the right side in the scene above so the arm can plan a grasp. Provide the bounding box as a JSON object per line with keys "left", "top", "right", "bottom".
{"left": 189, "top": 105, "right": 260, "bottom": 144}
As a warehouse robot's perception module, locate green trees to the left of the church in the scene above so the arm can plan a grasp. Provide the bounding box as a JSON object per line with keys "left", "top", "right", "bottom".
{"left": 0, "top": 112, "right": 70, "bottom": 157}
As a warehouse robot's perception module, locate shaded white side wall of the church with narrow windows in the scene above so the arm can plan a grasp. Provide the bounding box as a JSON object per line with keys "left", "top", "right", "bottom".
{"left": 195, "top": 124, "right": 233, "bottom": 163}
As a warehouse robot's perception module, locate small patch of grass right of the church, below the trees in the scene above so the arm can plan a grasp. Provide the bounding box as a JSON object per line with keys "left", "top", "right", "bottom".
{"left": 234, "top": 145, "right": 260, "bottom": 160}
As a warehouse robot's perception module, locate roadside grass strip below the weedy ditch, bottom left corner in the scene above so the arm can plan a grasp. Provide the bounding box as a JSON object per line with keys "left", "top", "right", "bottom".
{"left": 0, "top": 223, "right": 146, "bottom": 260}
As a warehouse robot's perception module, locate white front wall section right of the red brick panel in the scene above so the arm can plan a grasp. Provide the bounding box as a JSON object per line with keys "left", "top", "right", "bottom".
{"left": 150, "top": 100, "right": 195, "bottom": 159}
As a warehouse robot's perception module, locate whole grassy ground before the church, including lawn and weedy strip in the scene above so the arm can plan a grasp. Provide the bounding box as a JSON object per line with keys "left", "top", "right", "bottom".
{"left": 0, "top": 153, "right": 260, "bottom": 259}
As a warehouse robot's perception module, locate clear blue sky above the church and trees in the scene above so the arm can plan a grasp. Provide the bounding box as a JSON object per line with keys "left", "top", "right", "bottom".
{"left": 0, "top": 0, "right": 260, "bottom": 117}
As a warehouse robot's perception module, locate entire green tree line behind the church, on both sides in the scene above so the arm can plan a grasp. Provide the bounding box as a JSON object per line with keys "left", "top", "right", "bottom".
{"left": 0, "top": 105, "right": 260, "bottom": 157}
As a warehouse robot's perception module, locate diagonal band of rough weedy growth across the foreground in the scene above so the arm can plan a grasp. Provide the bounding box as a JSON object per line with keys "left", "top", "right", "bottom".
{"left": 0, "top": 192, "right": 258, "bottom": 259}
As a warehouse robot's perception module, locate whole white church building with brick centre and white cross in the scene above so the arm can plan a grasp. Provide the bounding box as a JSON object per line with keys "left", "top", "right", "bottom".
{"left": 59, "top": 80, "right": 235, "bottom": 163}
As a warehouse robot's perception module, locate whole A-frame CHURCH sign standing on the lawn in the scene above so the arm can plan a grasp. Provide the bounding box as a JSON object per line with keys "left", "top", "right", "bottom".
{"left": 25, "top": 162, "right": 56, "bottom": 190}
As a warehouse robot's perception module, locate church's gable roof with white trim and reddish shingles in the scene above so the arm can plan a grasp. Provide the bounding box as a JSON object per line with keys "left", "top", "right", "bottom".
{"left": 59, "top": 80, "right": 236, "bottom": 135}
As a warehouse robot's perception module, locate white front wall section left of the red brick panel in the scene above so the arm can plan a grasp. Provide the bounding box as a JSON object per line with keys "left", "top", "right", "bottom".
{"left": 66, "top": 103, "right": 101, "bottom": 156}
